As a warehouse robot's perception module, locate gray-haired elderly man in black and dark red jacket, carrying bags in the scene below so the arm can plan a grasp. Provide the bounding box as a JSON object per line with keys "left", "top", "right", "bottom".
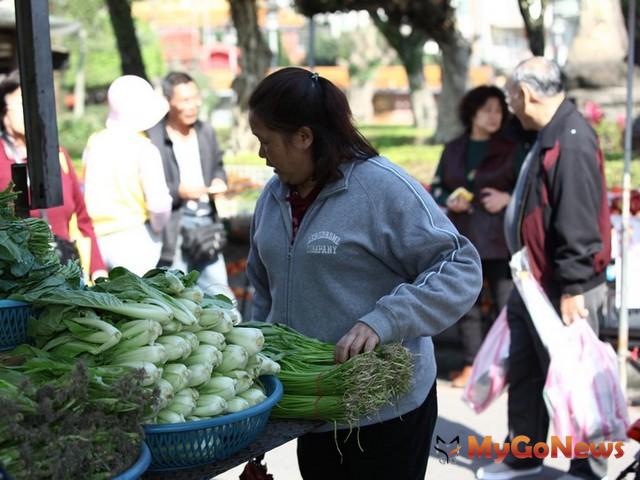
{"left": 476, "top": 57, "right": 611, "bottom": 480}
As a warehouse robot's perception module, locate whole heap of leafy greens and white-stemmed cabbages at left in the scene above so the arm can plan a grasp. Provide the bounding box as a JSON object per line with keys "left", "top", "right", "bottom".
{"left": 0, "top": 183, "right": 279, "bottom": 479}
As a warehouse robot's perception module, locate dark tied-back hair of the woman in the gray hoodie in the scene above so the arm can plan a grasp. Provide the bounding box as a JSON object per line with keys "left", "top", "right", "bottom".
{"left": 249, "top": 67, "right": 378, "bottom": 183}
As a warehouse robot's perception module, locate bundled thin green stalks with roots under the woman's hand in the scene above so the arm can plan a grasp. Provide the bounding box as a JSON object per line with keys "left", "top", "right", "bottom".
{"left": 246, "top": 322, "right": 413, "bottom": 425}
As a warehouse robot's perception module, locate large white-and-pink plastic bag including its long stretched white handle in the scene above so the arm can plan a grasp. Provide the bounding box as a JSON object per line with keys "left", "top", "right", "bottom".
{"left": 511, "top": 249, "right": 629, "bottom": 444}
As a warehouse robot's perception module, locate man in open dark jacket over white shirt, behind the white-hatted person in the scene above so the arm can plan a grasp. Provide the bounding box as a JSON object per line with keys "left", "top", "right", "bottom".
{"left": 148, "top": 72, "right": 233, "bottom": 298}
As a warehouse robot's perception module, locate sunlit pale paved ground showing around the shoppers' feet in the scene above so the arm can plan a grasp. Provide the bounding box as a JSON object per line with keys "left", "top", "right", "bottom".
{"left": 216, "top": 380, "right": 640, "bottom": 480}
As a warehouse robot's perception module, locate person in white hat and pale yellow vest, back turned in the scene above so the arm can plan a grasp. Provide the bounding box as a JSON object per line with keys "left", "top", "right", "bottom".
{"left": 82, "top": 75, "right": 171, "bottom": 275}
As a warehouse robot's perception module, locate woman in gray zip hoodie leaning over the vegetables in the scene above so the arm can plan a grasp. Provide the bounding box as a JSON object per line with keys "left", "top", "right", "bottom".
{"left": 247, "top": 68, "right": 482, "bottom": 480}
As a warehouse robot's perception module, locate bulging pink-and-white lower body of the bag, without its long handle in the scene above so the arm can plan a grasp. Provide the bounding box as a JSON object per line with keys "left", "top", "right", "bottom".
{"left": 544, "top": 321, "right": 629, "bottom": 444}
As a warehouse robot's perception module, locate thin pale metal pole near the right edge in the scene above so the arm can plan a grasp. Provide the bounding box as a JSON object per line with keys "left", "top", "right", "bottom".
{"left": 618, "top": 0, "right": 636, "bottom": 395}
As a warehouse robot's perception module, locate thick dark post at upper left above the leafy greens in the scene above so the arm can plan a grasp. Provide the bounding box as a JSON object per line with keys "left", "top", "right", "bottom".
{"left": 15, "top": 0, "right": 62, "bottom": 208}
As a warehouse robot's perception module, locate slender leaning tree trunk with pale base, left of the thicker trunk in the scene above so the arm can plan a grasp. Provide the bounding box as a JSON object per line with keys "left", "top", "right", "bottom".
{"left": 371, "top": 11, "right": 437, "bottom": 130}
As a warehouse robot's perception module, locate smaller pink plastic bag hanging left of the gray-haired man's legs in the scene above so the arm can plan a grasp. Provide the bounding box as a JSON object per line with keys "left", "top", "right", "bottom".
{"left": 462, "top": 307, "right": 511, "bottom": 413}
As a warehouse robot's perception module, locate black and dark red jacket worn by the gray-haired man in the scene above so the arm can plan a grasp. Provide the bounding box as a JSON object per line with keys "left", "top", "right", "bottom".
{"left": 520, "top": 100, "right": 611, "bottom": 297}
